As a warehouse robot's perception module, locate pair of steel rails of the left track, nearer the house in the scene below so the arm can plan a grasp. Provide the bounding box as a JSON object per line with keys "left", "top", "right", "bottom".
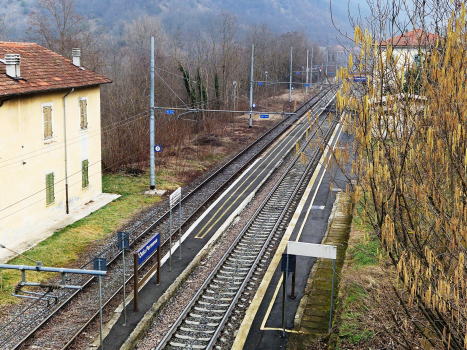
{"left": 2, "top": 86, "right": 334, "bottom": 349}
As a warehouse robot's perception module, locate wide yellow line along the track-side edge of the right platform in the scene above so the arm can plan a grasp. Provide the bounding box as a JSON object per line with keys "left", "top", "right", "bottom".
{"left": 231, "top": 123, "right": 342, "bottom": 350}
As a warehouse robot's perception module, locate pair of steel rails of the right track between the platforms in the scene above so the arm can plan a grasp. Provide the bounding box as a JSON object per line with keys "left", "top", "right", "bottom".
{"left": 156, "top": 94, "right": 335, "bottom": 350}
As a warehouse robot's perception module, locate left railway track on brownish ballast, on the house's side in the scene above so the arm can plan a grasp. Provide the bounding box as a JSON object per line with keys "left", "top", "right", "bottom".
{"left": 0, "top": 88, "right": 332, "bottom": 349}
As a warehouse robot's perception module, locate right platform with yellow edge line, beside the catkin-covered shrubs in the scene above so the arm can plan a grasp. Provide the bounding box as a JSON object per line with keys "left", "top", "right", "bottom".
{"left": 232, "top": 129, "right": 349, "bottom": 350}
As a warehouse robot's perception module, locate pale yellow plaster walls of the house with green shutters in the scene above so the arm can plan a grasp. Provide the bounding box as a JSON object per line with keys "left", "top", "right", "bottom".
{"left": 0, "top": 86, "right": 102, "bottom": 247}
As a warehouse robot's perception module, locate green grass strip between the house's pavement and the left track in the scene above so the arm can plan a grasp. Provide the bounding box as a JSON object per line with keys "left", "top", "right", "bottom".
{"left": 0, "top": 170, "right": 181, "bottom": 306}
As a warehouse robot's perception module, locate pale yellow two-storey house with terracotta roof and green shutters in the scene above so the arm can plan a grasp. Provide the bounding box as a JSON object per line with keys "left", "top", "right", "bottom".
{"left": 0, "top": 42, "right": 111, "bottom": 253}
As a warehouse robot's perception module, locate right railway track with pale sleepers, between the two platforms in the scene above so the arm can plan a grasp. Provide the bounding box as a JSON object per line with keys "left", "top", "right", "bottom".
{"left": 156, "top": 102, "right": 336, "bottom": 350}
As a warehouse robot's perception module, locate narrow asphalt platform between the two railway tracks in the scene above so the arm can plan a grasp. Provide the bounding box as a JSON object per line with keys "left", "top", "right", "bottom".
{"left": 98, "top": 108, "right": 318, "bottom": 349}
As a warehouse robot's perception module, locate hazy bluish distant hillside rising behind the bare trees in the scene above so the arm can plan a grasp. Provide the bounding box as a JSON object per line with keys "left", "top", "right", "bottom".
{"left": 0, "top": 0, "right": 357, "bottom": 44}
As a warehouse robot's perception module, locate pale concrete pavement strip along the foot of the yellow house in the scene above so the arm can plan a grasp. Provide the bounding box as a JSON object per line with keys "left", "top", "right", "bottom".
{"left": 0, "top": 193, "right": 120, "bottom": 264}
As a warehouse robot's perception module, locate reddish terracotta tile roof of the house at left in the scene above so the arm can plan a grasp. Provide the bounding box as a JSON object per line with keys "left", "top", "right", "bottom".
{"left": 0, "top": 41, "right": 112, "bottom": 97}
